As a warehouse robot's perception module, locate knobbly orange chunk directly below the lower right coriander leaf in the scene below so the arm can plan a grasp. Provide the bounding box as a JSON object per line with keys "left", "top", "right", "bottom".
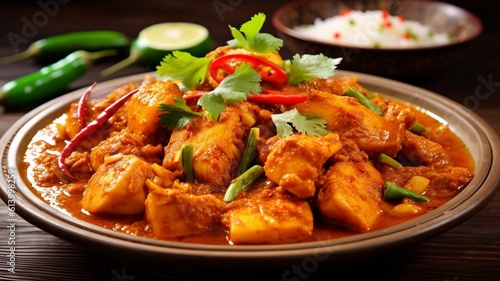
{"left": 264, "top": 134, "right": 342, "bottom": 198}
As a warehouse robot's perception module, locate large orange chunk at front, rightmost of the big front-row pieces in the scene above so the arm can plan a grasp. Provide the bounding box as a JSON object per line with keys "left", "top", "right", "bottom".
{"left": 317, "top": 160, "right": 383, "bottom": 232}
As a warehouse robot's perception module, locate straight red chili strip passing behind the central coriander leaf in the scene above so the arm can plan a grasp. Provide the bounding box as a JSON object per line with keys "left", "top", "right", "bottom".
{"left": 184, "top": 90, "right": 307, "bottom": 104}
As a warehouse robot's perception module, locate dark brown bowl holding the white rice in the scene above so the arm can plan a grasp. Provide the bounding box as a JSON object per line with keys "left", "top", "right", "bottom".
{"left": 272, "top": 0, "right": 482, "bottom": 79}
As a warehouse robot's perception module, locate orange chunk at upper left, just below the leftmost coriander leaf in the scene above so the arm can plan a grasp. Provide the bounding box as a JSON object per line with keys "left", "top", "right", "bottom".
{"left": 124, "top": 80, "right": 182, "bottom": 139}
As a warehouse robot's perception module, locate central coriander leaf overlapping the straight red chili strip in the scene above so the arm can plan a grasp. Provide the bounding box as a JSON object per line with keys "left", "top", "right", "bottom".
{"left": 198, "top": 63, "right": 261, "bottom": 120}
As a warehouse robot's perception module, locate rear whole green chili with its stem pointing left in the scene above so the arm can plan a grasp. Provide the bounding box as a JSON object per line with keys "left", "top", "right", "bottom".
{"left": 0, "top": 30, "right": 130, "bottom": 65}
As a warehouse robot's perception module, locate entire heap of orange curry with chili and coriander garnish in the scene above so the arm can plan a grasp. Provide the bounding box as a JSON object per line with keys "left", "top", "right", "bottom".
{"left": 22, "top": 14, "right": 474, "bottom": 245}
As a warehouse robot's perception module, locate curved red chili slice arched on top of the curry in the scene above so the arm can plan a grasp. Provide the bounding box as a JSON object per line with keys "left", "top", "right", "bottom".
{"left": 209, "top": 54, "right": 288, "bottom": 85}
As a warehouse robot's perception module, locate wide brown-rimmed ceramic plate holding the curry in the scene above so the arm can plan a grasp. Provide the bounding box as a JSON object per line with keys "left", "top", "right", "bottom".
{"left": 0, "top": 70, "right": 500, "bottom": 280}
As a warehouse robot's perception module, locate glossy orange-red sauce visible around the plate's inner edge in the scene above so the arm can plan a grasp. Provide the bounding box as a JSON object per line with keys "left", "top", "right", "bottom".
{"left": 21, "top": 95, "right": 474, "bottom": 244}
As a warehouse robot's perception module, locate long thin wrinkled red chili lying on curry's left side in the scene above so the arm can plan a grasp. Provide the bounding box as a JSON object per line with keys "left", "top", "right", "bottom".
{"left": 57, "top": 86, "right": 139, "bottom": 180}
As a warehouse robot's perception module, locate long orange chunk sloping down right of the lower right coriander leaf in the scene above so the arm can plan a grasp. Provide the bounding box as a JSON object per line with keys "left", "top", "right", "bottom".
{"left": 295, "top": 90, "right": 406, "bottom": 157}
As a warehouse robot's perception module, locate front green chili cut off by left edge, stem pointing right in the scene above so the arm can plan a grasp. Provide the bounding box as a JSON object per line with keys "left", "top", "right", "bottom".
{"left": 0, "top": 50, "right": 116, "bottom": 107}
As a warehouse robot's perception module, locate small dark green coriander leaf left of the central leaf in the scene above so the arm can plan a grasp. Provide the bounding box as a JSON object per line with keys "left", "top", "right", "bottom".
{"left": 158, "top": 98, "right": 203, "bottom": 130}
